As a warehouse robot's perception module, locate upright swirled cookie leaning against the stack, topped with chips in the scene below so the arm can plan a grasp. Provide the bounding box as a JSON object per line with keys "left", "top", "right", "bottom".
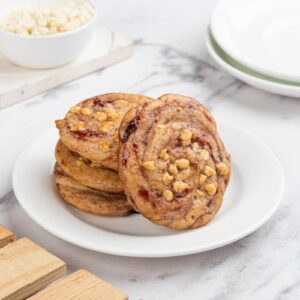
{"left": 119, "top": 94, "right": 230, "bottom": 229}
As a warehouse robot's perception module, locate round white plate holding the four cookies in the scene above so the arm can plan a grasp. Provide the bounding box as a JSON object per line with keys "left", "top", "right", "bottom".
{"left": 13, "top": 123, "right": 283, "bottom": 257}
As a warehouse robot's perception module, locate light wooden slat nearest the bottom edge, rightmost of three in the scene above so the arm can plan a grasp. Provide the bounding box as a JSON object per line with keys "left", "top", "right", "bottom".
{"left": 29, "top": 270, "right": 128, "bottom": 300}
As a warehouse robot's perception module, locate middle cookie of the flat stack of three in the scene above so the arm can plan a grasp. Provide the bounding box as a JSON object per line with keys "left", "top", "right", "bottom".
{"left": 55, "top": 140, "right": 124, "bottom": 193}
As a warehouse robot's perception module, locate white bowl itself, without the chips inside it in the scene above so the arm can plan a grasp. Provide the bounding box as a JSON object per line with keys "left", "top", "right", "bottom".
{"left": 0, "top": 0, "right": 97, "bottom": 69}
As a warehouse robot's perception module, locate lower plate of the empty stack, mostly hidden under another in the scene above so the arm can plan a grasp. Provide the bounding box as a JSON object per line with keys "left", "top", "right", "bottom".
{"left": 206, "top": 30, "right": 300, "bottom": 98}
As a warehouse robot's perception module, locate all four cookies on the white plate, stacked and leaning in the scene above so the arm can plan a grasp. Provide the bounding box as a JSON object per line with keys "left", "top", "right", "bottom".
{"left": 55, "top": 94, "right": 230, "bottom": 229}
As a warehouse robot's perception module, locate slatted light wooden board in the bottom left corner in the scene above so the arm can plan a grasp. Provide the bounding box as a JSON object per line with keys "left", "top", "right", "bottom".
{"left": 0, "top": 225, "right": 128, "bottom": 300}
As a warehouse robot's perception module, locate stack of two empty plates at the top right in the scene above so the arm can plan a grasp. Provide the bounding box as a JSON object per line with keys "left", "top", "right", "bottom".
{"left": 206, "top": 0, "right": 300, "bottom": 97}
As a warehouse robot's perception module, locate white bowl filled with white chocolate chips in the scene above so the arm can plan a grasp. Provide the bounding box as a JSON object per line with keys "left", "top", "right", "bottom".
{"left": 0, "top": 0, "right": 96, "bottom": 69}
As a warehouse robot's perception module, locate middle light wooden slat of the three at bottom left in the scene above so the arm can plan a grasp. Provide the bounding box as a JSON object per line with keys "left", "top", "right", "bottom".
{"left": 0, "top": 238, "right": 66, "bottom": 300}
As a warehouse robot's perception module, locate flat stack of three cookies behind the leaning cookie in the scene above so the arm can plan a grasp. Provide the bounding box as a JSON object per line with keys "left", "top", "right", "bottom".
{"left": 54, "top": 94, "right": 152, "bottom": 216}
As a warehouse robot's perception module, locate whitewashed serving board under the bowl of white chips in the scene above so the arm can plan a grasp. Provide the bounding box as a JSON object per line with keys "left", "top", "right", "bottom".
{"left": 0, "top": 27, "right": 133, "bottom": 109}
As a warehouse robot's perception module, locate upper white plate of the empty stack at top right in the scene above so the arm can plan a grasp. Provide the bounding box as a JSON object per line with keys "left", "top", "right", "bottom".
{"left": 211, "top": 0, "right": 300, "bottom": 82}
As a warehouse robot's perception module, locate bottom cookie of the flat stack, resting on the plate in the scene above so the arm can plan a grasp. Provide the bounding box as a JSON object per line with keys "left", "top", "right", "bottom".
{"left": 54, "top": 164, "right": 133, "bottom": 217}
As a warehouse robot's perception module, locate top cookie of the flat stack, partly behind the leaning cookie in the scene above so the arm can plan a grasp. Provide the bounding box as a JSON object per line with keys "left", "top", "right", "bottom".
{"left": 56, "top": 94, "right": 152, "bottom": 170}
